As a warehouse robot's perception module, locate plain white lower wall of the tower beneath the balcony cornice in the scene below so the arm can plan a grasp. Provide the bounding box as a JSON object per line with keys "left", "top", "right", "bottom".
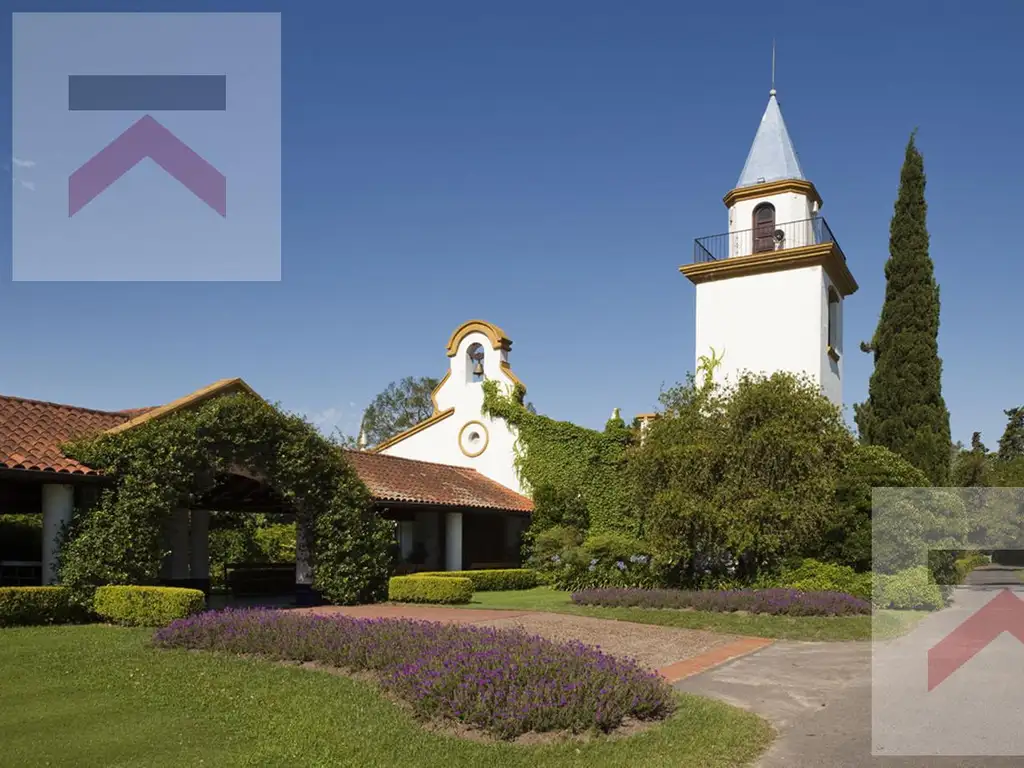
{"left": 696, "top": 266, "right": 843, "bottom": 404}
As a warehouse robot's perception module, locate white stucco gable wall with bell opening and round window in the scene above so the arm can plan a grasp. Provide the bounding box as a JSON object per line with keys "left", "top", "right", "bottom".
{"left": 381, "top": 332, "right": 526, "bottom": 494}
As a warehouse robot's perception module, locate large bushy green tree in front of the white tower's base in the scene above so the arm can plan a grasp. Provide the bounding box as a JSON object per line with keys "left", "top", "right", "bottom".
{"left": 630, "top": 373, "right": 854, "bottom": 584}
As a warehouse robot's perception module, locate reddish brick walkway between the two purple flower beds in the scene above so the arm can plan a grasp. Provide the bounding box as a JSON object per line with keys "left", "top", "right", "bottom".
{"left": 299, "top": 603, "right": 771, "bottom": 682}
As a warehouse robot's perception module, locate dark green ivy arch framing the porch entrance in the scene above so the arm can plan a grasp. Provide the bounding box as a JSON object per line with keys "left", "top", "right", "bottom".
{"left": 59, "top": 394, "right": 393, "bottom": 603}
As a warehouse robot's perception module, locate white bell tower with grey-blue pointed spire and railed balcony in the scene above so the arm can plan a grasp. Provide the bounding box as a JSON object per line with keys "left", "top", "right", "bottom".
{"left": 679, "top": 88, "right": 857, "bottom": 407}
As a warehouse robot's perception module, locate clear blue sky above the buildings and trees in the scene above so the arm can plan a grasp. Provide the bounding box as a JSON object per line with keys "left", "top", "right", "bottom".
{"left": 0, "top": 0, "right": 1024, "bottom": 445}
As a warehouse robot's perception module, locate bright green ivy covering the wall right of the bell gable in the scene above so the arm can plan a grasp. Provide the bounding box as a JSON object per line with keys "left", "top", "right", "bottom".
{"left": 483, "top": 381, "right": 636, "bottom": 534}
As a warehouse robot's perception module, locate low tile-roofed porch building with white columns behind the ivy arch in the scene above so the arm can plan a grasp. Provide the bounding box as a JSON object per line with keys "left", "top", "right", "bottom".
{"left": 0, "top": 387, "right": 532, "bottom": 602}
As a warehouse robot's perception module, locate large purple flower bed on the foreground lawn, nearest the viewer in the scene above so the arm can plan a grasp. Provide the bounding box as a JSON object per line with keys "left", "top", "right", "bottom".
{"left": 154, "top": 609, "right": 674, "bottom": 738}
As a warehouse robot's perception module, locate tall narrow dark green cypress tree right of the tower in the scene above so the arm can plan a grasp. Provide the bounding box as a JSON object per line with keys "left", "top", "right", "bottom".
{"left": 854, "top": 131, "right": 951, "bottom": 485}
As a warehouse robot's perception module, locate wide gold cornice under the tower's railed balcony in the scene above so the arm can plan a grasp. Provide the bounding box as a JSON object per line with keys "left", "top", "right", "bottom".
{"left": 679, "top": 243, "right": 859, "bottom": 297}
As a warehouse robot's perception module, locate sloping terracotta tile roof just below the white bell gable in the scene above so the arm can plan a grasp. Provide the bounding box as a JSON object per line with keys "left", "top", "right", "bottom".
{"left": 346, "top": 451, "right": 534, "bottom": 512}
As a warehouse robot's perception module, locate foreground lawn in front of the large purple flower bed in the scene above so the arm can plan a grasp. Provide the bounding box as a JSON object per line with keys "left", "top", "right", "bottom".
{"left": 0, "top": 625, "right": 772, "bottom": 768}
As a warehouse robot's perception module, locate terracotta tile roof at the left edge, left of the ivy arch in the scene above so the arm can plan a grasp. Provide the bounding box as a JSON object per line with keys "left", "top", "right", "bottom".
{"left": 0, "top": 395, "right": 133, "bottom": 475}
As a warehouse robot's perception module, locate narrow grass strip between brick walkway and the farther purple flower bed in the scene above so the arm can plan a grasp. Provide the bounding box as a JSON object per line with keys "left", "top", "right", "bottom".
{"left": 465, "top": 587, "right": 927, "bottom": 641}
